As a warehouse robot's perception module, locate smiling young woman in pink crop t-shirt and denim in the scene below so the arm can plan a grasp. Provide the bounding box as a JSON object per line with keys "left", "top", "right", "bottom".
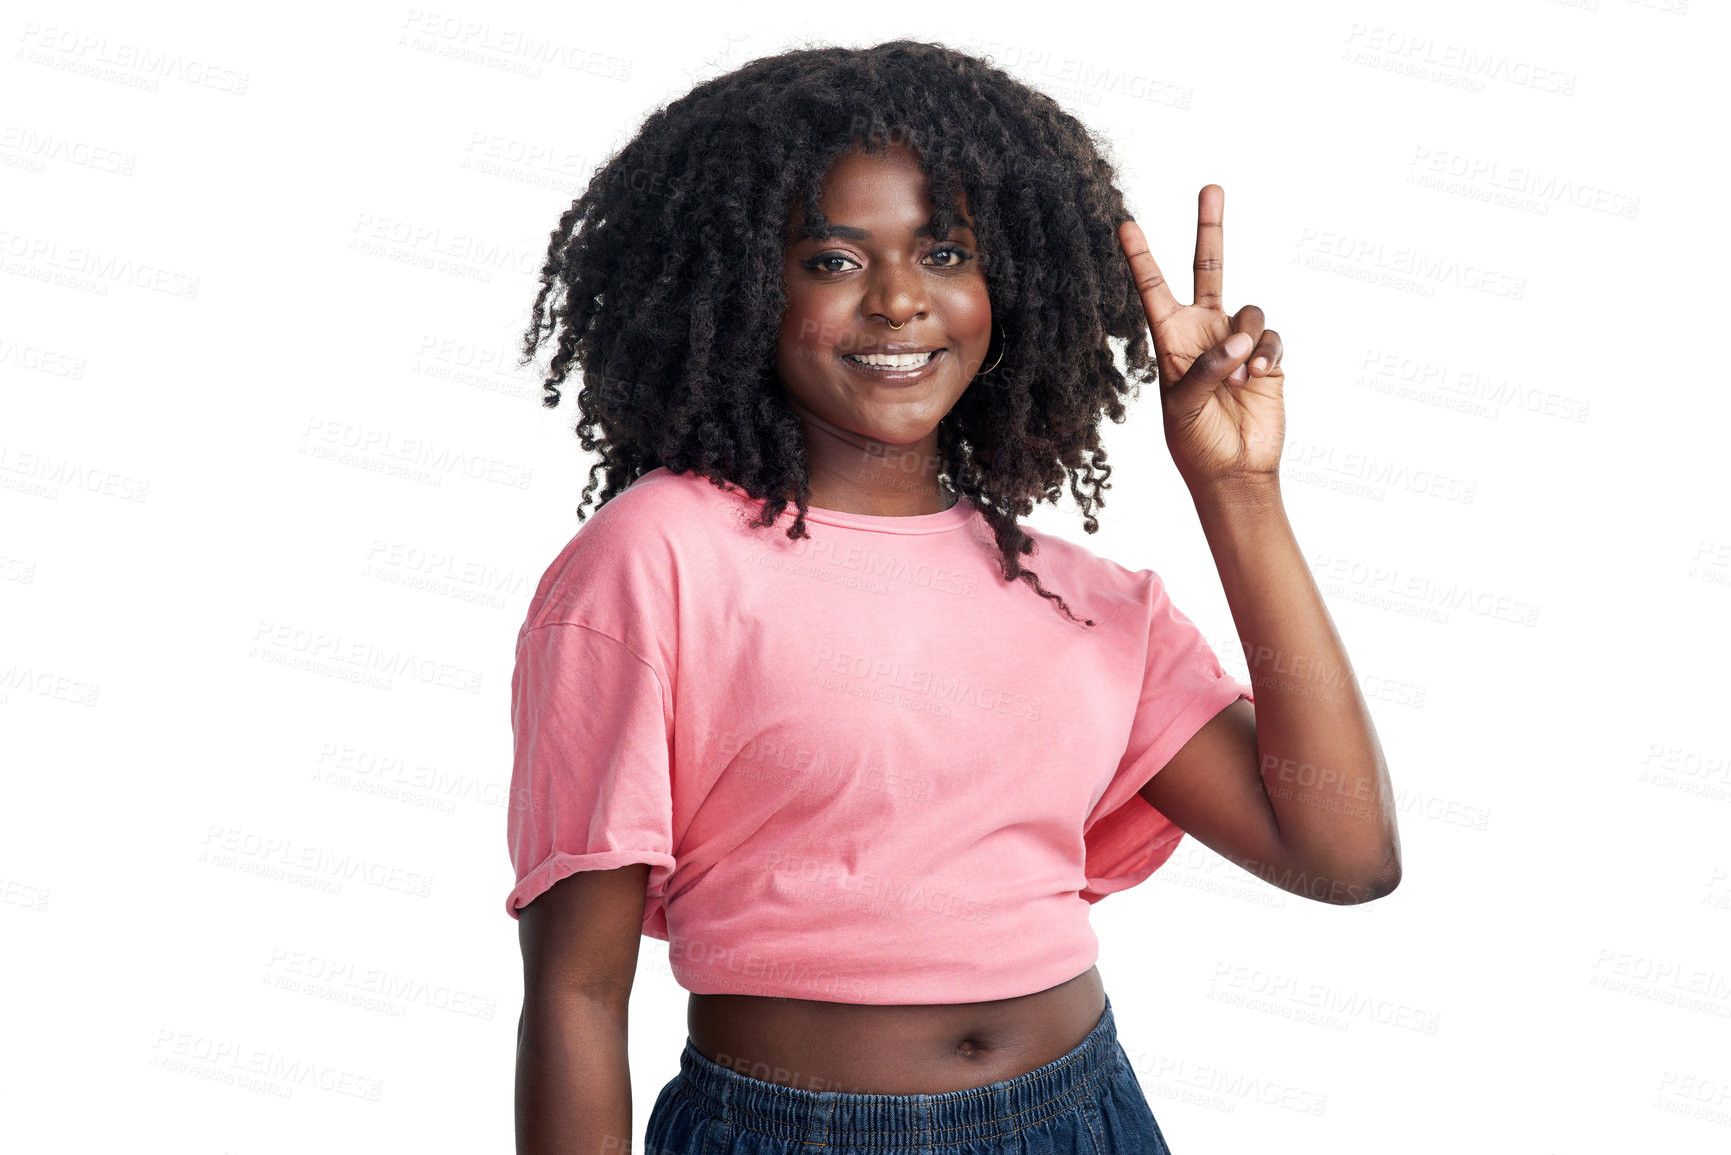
{"left": 505, "top": 42, "right": 1400, "bottom": 1155}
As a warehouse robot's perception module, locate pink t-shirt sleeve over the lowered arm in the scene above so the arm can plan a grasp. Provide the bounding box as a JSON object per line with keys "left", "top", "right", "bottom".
{"left": 505, "top": 622, "right": 675, "bottom": 933}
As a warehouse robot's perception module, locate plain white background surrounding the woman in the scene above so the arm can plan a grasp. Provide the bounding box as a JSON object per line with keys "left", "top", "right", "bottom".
{"left": 0, "top": 0, "right": 1731, "bottom": 1155}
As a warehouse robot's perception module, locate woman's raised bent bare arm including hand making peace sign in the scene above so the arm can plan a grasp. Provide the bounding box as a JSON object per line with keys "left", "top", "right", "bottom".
{"left": 1118, "top": 185, "right": 1400, "bottom": 906}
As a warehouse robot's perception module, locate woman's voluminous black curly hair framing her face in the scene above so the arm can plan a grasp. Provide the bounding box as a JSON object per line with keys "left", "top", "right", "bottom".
{"left": 519, "top": 40, "right": 1156, "bottom": 625}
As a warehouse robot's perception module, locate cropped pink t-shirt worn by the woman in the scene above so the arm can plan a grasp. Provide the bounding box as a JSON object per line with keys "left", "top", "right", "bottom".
{"left": 505, "top": 468, "right": 1253, "bottom": 1004}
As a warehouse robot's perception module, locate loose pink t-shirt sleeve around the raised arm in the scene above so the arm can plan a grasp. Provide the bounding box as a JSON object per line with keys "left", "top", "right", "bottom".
{"left": 1082, "top": 571, "right": 1255, "bottom": 902}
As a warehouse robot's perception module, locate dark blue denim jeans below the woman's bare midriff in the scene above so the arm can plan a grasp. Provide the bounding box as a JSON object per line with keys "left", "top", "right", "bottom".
{"left": 644, "top": 999, "right": 1172, "bottom": 1155}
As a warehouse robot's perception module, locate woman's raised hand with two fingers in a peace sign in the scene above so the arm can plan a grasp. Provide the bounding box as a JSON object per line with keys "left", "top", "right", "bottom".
{"left": 1118, "top": 185, "right": 1286, "bottom": 488}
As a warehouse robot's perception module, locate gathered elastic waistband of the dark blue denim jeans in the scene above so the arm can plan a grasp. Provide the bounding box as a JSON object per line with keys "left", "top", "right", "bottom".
{"left": 679, "top": 997, "right": 1118, "bottom": 1148}
